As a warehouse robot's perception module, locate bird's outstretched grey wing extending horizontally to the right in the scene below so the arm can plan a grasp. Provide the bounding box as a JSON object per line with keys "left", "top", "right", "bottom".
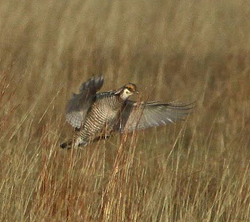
{"left": 116, "top": 100, "right": 195, "bottom": 132}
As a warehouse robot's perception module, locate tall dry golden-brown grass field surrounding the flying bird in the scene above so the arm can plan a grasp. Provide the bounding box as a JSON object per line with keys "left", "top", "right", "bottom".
{"left": 0, "top": 0, "right": 250, "bottom": 222}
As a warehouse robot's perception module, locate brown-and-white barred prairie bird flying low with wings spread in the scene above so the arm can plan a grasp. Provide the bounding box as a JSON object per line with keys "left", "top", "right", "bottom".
{"left": 60, "top": 76, "right": 194, "bottom": 149}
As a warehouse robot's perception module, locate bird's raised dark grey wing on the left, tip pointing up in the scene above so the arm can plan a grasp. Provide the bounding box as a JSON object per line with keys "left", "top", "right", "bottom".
{"left": 66, "top": 77, "right": 104, "bottom": 128}
